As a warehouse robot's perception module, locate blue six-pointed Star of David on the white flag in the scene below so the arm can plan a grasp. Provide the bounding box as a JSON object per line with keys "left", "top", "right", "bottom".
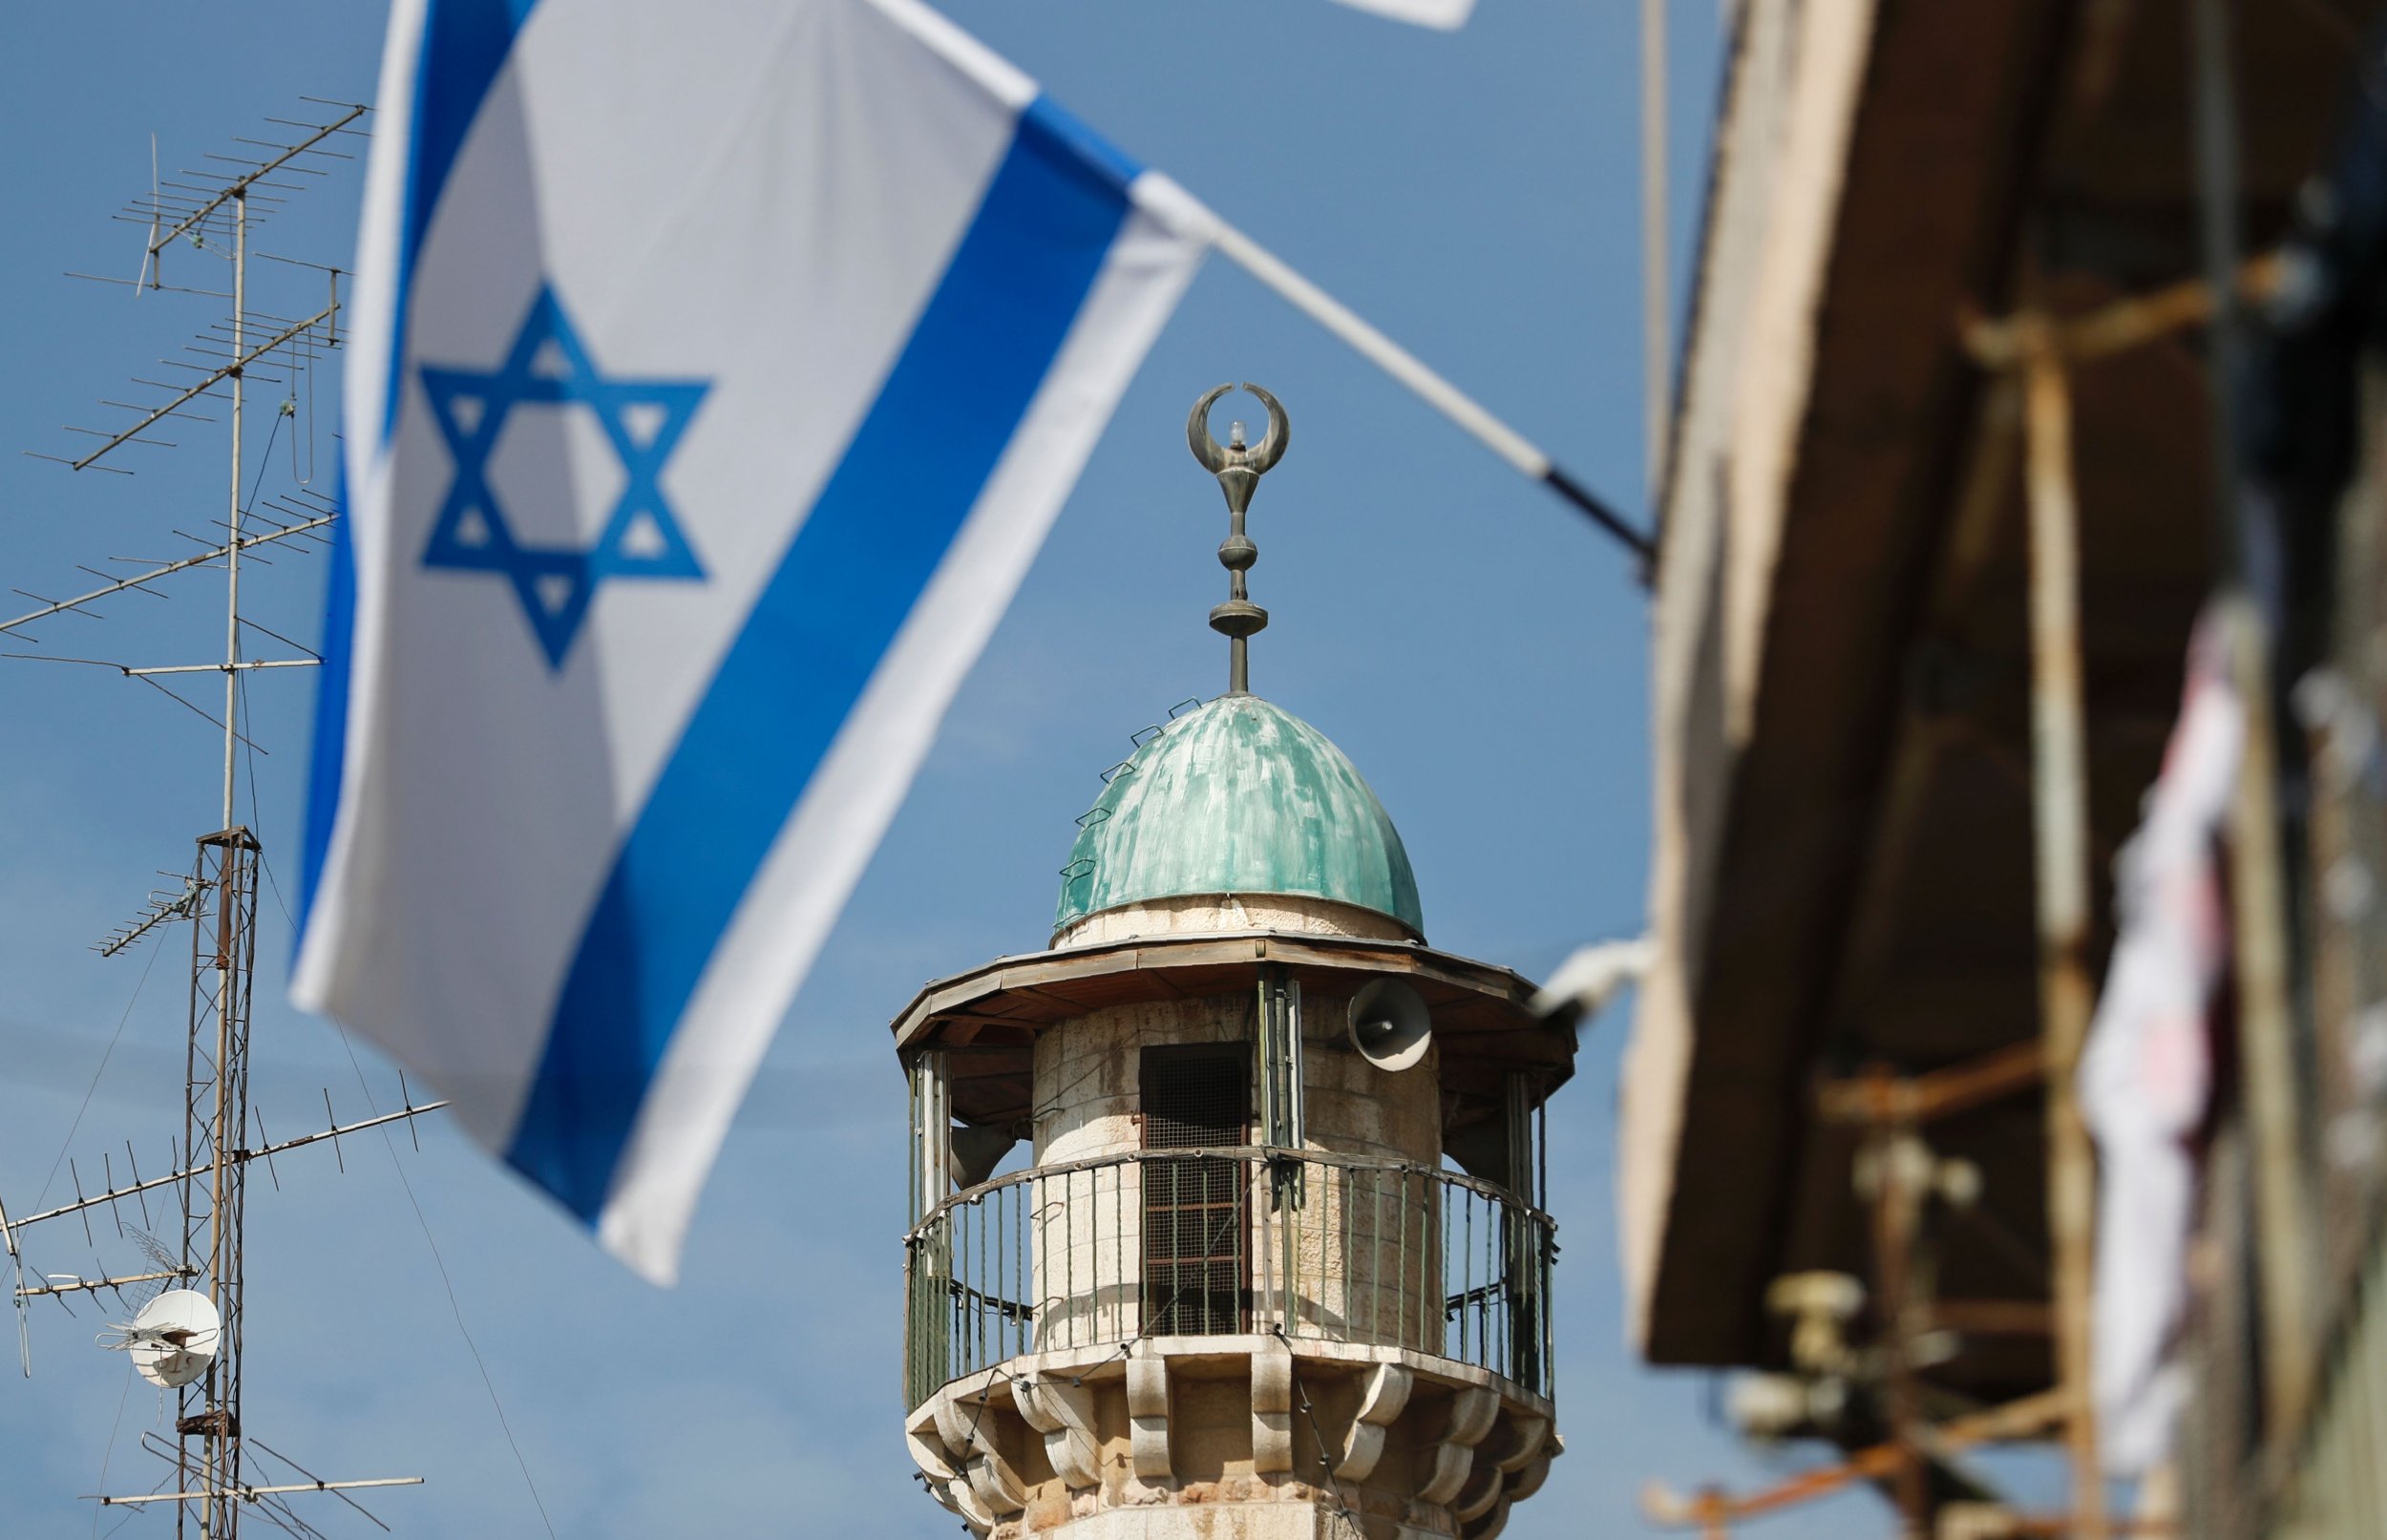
{"left": 418, "top": 285, "right": 711, "bottom": 668}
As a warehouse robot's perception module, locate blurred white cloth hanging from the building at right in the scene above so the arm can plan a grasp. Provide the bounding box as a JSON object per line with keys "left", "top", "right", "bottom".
{"left": 2080, "top": 611, "right": 2247, "bottom": 1475}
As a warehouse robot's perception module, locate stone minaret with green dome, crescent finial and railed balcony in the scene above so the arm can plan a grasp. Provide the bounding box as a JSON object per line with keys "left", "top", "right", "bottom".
{"left": 896, "top": 385, "right": 1575, "bottom": 1540}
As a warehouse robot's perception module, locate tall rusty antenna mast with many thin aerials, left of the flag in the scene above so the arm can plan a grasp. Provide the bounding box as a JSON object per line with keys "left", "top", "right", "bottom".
{"left": 0, "top": 98, "right": 444, "bottom": 1540}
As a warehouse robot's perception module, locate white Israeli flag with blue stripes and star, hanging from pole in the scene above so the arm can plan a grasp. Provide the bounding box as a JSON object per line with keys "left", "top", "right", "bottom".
{"left": 294, "top": 0, "right": 1215, "bottom": 1282}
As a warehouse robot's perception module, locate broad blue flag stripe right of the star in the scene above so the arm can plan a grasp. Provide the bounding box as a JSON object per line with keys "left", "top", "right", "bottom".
{"left": 506, "top": 108, "right": 1127, "bottom": 1222}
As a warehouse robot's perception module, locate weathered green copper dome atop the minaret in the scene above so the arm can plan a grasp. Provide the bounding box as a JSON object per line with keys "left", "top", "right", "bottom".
{"left": 1053, "top": 695, "right": 1426, "bottom": 939}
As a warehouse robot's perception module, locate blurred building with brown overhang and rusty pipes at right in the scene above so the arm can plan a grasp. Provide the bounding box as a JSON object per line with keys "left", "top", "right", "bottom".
{"left": 1618, "top": 0, "right": 2387, "bottom": 1540}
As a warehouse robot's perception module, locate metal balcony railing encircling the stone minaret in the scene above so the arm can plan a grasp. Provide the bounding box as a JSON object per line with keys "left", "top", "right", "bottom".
{"left": 905, "top": 1146, "right": 1556, "bottom": 1406}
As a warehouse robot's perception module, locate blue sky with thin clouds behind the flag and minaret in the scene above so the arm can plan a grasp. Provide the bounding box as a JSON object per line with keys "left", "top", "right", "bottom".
{"left": 0, "top": 0, "right": 1876, "bottom": 1540}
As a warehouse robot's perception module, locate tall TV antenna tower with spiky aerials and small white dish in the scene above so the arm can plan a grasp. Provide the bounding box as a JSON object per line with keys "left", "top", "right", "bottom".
{"left": 0, "top": 98, "right": 447, "bottom": 1540}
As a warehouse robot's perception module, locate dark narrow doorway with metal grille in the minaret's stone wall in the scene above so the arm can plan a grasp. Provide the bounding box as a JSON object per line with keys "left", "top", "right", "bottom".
{"left": 1141, "top": 1044, "right": 1251, "bottom": 1337}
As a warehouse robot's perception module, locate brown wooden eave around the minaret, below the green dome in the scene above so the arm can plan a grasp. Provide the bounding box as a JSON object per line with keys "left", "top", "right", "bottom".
{"left": 893, "top": 931, "right": 1575, "bottom": 1129}
